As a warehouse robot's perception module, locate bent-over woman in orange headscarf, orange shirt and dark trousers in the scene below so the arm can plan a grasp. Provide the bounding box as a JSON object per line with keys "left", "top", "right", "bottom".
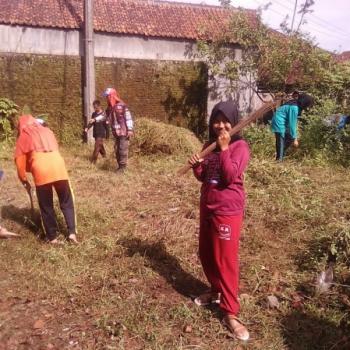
{"left": 15, "top": 115, "right": 78, "bottom": 244}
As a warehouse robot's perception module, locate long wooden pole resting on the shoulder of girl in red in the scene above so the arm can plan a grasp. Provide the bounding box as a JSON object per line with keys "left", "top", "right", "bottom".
{"left": 177, "top": 101, "right": 277, "bottom": 176}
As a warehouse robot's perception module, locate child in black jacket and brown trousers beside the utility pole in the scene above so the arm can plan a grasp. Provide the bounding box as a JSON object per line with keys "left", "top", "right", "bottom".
{"left": 85, "top": 100, "right": 108, "bottom": 163}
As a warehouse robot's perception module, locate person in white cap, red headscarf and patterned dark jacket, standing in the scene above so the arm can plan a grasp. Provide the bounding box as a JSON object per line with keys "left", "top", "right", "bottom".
{"left": 103, "top": 88, "right": 134, "bottom": 172}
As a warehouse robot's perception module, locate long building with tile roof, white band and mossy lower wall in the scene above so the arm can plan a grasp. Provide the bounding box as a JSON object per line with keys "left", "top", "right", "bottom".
{"left": 0, "top": 0, "right": 255, "bottom": 141}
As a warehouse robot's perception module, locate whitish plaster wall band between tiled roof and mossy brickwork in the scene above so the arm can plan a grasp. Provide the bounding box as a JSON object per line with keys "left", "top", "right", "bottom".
{"left": 0, "top": 25, "right": 195, "bottom": 61}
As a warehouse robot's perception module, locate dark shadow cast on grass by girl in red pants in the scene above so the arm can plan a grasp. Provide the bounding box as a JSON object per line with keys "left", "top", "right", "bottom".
{"left": 118, "top": 238, "right": 208, "bottom": 297}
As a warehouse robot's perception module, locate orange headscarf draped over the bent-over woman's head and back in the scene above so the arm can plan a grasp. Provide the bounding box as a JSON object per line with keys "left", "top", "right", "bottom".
{"left": 15, "top": 115, "right": 58, "bottom": 158}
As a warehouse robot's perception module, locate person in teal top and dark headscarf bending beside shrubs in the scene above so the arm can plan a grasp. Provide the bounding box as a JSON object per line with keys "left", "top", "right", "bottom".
{"left": 271, "top": 94, "right": 313, "bottom": 161}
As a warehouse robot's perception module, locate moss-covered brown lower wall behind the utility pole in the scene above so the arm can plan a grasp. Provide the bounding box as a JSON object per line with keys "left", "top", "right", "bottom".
{"left": 0, "top": 54, "right": 207, "bottom": 143}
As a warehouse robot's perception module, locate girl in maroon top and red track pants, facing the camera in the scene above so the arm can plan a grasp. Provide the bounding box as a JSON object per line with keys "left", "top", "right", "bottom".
{"left": 189, "top": 101, "right": 249, "bottom": 340}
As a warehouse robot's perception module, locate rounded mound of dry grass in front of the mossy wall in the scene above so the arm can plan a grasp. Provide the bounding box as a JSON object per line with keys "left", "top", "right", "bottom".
{"left": 131, "top": 118, "right": 201, "bottom": 156}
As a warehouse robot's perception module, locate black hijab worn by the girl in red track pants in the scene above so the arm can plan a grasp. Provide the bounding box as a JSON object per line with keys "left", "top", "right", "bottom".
{"left": 209, "top": 101, "right": 241, "bottom": 142}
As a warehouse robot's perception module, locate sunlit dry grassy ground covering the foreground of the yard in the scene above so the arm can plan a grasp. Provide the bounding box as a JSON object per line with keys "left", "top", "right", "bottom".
{"left": 0, "top": 140, "right": 350, "bottom": 350}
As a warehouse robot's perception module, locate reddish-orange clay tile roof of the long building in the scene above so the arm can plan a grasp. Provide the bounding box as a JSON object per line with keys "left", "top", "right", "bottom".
{"left": 0, "top": 0, "right": 255, "bottom": 39}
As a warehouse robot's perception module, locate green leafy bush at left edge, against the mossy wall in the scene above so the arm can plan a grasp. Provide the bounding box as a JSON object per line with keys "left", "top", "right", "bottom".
{"left": 0, "top": 98, "right": 18, "bottom": 141}
